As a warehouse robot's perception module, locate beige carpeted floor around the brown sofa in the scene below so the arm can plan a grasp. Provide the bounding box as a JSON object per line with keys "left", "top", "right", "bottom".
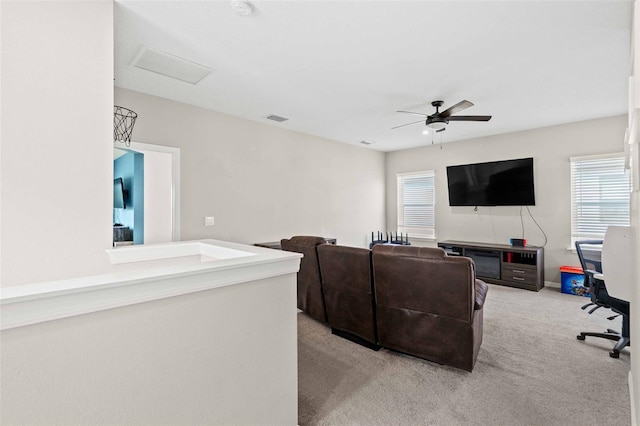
{"left": 298, "top": 285, "right": 631, "bottom": 426}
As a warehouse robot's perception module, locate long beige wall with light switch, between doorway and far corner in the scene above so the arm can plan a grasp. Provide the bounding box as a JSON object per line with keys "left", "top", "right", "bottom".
{"left": 115, "top": 88, "right": 385, "bottom": 247}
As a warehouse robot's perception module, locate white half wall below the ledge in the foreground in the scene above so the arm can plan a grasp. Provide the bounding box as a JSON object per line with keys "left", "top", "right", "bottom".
{"left": 0, "top": 273, "right": 298, "bottom": 425}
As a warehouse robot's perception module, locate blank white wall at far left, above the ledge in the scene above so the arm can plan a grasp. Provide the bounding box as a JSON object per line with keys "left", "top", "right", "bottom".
{"left": 0, "top": 1, "right": 113, "bottom": 286}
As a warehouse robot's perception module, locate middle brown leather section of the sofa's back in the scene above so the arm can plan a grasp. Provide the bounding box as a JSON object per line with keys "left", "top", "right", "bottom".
{"left": 318, "top": 244, "right": 379, "bottom": 349}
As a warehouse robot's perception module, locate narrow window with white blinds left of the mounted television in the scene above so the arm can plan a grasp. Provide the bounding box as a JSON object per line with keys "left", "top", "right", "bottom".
{"left": 396, "top": 170, "right": 436, "bottom": 238}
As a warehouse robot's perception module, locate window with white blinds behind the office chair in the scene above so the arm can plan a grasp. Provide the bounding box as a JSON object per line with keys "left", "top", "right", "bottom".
{"left": 570, "top": 154, "right": 631, "bottom": 246}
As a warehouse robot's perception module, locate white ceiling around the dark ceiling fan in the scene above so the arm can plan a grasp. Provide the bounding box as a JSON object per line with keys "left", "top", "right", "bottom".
{"left": 115, "top": 0, "right": 632, "bottom": 151}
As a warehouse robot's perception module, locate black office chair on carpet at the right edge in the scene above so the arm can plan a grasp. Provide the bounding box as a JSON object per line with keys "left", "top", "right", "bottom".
{"left": 576, "top": 240, "right": 630, "bottom": 358}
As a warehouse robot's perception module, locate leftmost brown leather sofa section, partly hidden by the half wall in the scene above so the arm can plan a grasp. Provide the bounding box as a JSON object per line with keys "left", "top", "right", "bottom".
{"left": 280, "top": 236, "right": 327, "bottom": 322}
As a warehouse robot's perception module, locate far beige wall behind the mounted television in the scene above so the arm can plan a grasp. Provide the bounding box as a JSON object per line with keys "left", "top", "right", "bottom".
{"left": 386, "top": 116, "right": 627, "bottom": 283}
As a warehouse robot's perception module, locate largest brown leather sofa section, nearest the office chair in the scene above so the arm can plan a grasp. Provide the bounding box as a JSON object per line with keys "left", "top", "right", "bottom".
{"left": 373, "top": 245, "right": 488, "bottom": 371}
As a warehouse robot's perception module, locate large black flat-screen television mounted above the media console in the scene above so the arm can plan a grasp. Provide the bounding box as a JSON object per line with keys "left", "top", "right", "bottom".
{"left": 447, "top": 158, "right": 536, "bottom": 206}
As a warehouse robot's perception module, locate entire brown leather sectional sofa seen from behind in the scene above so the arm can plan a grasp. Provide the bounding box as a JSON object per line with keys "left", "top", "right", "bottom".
{"left": 282, "top": 237, "right": 488, "bottom": 371}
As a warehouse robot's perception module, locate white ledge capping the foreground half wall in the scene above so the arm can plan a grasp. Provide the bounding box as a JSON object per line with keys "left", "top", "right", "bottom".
{"left": 0, "top": 240, "right": 302, "bottom": 330}
